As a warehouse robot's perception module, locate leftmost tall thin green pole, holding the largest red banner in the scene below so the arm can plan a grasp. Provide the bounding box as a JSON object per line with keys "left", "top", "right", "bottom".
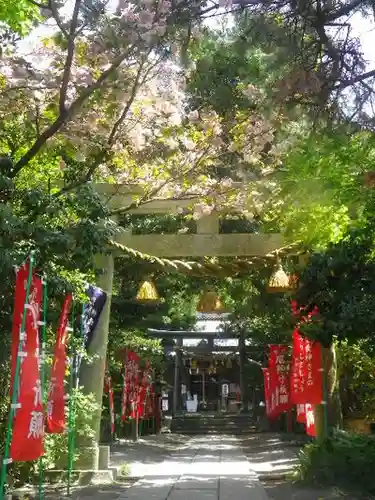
{"left": 0, "top": 252, "right": 34, "bottom": 500}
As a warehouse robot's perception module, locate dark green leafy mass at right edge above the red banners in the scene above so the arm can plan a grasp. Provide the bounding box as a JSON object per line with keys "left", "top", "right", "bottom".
{"left": 297, "top": 206, "right": 375, "bottom": 345}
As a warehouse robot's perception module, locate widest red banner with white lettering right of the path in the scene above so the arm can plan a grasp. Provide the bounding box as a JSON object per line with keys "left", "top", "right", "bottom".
{"left": 290, "top": 328, "right": 323, "bottom": 404}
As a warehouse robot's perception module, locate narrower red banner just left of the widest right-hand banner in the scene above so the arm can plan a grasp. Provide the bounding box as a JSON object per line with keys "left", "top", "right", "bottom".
{"left": 269, "top": 345, "right": 291, "bottom": 417}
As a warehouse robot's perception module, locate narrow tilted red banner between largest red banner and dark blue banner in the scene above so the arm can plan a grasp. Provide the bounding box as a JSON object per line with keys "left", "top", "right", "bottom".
{"left": 47, "top": 295, "right": 73, "bottom": 434}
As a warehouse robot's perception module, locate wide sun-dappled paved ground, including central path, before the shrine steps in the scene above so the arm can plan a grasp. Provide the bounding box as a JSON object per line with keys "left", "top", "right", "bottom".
{"left": 33, "top": 433, "right": 308, "bottom": 500}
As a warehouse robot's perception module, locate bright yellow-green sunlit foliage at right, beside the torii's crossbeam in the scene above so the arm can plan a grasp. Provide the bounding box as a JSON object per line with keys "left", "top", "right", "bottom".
{"left": 274, "top": 129, "right": 375, "bottom": 248}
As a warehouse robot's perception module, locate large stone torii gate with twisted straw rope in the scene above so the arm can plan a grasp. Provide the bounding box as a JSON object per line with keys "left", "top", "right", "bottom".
{"left": 80, "top": 184, "right": 292, "bottom": 470}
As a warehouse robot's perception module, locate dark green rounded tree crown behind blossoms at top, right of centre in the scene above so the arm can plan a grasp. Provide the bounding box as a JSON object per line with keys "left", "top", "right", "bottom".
{"left": 188, "top": 11, "right": 312, "bottom": 119}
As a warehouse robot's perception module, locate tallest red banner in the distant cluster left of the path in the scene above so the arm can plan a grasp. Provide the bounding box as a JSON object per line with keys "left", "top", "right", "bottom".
{"left": 121, "top": 351, "right": 139, "bottom": 420}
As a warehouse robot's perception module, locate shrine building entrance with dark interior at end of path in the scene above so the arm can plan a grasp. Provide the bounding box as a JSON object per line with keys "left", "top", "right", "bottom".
{"left": 148, "top": 310, "right": 248, "bottom": 415}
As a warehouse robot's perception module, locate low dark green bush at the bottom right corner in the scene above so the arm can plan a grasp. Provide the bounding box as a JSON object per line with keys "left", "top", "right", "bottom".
{"left": 297, "top": 431, "right": 375, "bottom": 494}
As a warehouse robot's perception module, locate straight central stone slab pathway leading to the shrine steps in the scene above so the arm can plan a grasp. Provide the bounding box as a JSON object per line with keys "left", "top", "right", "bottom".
{"left": 112, "top": 435, "right": 268, "bottom": 500}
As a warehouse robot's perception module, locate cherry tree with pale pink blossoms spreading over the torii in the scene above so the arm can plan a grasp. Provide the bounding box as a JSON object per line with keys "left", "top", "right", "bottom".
{"left": 0, "top": 0, "right": 296, "bottom": 223}
